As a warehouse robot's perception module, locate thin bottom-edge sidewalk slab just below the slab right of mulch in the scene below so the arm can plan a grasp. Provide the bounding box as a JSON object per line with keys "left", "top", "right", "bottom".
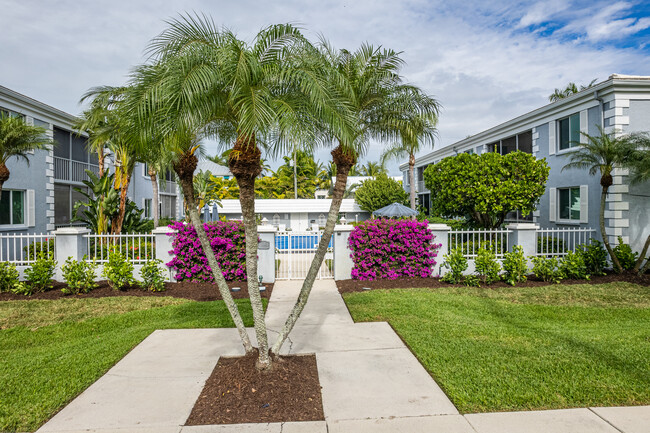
{"left": 328, "top": 415, "right": 476, "bottom": 433}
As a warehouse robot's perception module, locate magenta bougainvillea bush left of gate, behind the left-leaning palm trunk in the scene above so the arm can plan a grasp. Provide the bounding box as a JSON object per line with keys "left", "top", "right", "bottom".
{"left": 167, "top": 221, "right": 246, "bottom": 282}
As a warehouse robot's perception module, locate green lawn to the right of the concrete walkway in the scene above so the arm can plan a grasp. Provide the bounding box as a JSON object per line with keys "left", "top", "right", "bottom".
{"left": 344, "top": 283, "right": 650, "bottom": 413}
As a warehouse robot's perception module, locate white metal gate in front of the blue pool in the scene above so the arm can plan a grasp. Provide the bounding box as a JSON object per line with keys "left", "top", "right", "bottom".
{"left": 275, "top": 231, "right": 334, "bottom": 280}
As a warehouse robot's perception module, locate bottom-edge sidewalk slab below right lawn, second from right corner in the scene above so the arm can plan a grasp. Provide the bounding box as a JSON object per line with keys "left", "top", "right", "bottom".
{"left": 465, "top": 409, "right": 620, "bottom": 433}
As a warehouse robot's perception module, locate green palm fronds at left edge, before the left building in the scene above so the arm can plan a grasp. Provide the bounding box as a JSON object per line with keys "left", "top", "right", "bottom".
{"left": 0, "top": 111, "right": 52, "bottom": 197}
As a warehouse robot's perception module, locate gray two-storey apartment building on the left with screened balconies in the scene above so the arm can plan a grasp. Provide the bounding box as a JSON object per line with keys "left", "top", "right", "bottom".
{"left": 0, "top": 86, "right": 182, "bottom": 233}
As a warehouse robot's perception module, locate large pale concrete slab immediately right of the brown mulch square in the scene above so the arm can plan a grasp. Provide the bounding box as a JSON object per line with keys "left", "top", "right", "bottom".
{"left": 316, "top": 348, "right": 458, "bottom": 421}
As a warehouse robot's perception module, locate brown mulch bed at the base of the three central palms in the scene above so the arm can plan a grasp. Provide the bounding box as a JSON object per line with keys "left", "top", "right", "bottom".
{"left": 185, "top": 352, "right": 325, "bottom": 425}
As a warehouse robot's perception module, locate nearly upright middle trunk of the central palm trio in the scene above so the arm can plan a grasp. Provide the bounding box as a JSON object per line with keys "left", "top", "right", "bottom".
{"left": 228, "top": 136, "right": 271, "bottom": 370}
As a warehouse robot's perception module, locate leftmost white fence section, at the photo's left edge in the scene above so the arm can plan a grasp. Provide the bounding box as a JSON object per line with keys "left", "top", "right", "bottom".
{"left": 0, "top": 233, "right": 56, "bottom": 266}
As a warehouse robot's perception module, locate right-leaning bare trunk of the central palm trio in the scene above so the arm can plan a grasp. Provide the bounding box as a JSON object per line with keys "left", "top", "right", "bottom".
{"left": 271, "top": 145, "right": 356, "bottom": 356}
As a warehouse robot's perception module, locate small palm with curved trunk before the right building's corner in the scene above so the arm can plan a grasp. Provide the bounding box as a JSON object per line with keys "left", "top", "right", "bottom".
{"left": 562, "top": 126, "right": 633, "bottom": 272}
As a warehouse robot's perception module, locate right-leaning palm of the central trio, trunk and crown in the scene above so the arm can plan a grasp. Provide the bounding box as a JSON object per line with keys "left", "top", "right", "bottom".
{"left": 271, "top": 41, "right": 438, "bottom": 354}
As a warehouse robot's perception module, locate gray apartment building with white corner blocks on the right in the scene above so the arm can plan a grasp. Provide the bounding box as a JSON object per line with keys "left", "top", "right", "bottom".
{"left": 400, "top": 74, "right": 650, "bottom": 251}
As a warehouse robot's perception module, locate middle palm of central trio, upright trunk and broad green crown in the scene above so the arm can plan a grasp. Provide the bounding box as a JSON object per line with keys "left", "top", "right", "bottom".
{"left": 128, "top": 16, "right": 344, "bottom": 369}
